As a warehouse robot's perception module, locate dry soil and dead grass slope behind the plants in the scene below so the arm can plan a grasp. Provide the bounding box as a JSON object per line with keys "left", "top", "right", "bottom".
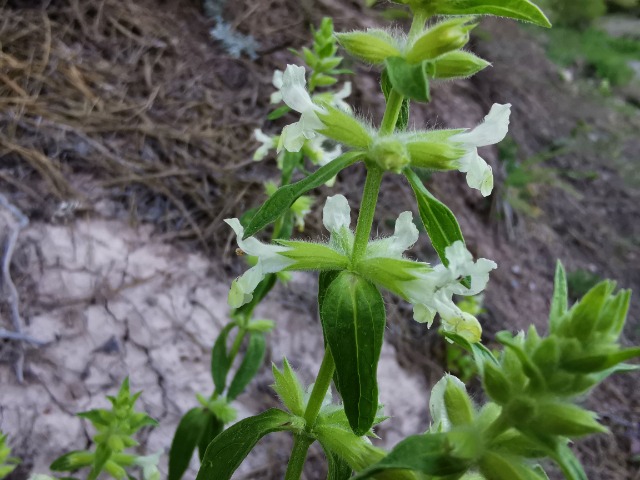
{"left": 0, "top": 0, "right": 640, "bottom": 480}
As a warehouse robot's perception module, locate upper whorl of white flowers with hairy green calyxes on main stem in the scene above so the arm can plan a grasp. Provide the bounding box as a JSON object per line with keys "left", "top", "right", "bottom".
{"left": 268, "top": 65, "right": 511, "bottom": 196}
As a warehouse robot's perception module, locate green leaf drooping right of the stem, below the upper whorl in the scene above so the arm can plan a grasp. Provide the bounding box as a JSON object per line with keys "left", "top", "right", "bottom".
{"left": 404, "top": 168, "right": 464, "bottom": 266}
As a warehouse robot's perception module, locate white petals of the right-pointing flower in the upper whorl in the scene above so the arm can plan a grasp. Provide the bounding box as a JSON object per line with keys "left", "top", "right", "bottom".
{"left": 450, "top": 103, "right": 511, "bottom": 197}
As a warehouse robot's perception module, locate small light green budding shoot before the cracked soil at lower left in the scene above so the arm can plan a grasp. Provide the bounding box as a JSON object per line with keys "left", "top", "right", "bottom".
{"left": 50, "top": 378, "right": 160, "bottom": 480}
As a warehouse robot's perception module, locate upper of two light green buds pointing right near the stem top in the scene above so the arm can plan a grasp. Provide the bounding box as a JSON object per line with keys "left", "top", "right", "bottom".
{"left": 406, "top": 17, "right": 477, "bottom": 63}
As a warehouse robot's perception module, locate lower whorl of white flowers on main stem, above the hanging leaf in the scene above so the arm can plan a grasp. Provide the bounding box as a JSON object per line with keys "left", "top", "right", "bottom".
{"left": 226, "top": 195, "right": 496, "bottom": 342}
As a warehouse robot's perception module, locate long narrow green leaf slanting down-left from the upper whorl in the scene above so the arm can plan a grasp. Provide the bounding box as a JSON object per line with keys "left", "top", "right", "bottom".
{"left": 244, "top": 152, "right": 364, "bottom": 238}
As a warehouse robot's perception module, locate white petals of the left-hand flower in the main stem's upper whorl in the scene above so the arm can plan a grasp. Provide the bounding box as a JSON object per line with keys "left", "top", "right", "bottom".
{"left": 278, "top": 65, "right": 324, "bottom": 152}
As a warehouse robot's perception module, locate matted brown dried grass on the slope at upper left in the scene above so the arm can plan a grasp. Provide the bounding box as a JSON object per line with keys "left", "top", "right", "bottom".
{"left": 0, "top": 0, "right": 322, "bottom": 247}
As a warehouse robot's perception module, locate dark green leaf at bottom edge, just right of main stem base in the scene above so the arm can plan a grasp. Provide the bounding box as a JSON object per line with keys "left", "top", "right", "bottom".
{"left": 353, "top": 434, "right": 469, "bottom": 480}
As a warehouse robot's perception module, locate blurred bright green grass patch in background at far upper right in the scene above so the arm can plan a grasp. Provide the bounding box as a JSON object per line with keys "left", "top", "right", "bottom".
{"left": 547, "top": 28, "right": 640, "bottom": 87}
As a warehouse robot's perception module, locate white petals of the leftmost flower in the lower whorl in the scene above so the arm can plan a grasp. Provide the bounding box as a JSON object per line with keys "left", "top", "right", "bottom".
{"left": 225, "top": 218, "right": 295, "bottom": 308}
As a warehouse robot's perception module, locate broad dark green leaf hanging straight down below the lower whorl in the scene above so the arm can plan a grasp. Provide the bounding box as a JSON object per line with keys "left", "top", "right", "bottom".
{"left": 320, "top": 272, "right": 386, "bottom": 435}
